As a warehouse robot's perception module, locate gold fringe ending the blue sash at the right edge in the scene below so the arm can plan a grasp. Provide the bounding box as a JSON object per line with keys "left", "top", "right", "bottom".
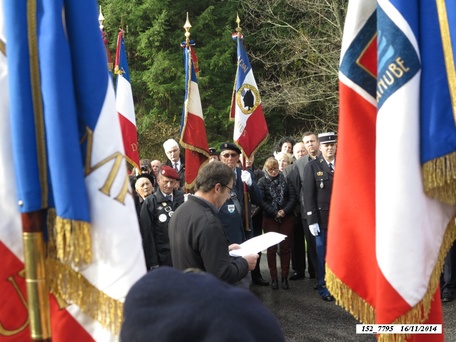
{"left": 423, "top": 152, "right": 456, "bottom": 205}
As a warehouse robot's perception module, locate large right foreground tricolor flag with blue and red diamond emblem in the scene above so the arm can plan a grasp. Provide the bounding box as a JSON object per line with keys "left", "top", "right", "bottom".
{"left": 326, "top": 0, "right": 456, "bottom": 341}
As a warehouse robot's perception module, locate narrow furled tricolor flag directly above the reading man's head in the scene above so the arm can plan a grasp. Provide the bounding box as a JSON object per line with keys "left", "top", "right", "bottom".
{"left": 179, "top": 43, "right": 209, "bottom": 189}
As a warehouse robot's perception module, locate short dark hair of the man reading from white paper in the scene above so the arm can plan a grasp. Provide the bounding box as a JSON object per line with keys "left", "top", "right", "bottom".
{"left": 195, "top": 161, "right": 234, "bottom": 192}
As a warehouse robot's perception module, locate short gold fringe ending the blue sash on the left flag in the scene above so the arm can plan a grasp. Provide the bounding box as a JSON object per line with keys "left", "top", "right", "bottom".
{"left": 47, "top": 209, "right": 92, "bottom": 268}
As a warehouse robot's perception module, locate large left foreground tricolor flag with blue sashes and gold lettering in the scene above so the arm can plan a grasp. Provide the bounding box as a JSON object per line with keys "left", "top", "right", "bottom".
{"left": 0, "top": 0, "right": 145, "bottom": 341}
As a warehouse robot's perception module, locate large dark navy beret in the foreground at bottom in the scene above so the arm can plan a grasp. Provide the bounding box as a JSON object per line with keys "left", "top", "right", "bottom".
{"left": 120, "top": 266, "right": 285, "bottom": 342}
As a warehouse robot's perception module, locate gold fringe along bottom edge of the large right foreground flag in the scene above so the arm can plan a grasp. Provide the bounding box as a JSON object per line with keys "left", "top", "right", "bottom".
{"left": 326, "top": 216, "right": 456, "bottom": 342}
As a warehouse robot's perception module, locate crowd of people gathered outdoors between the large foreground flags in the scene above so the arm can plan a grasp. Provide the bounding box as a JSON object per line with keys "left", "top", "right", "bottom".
{"left": 122, "top": 132, "right": 456, "bottom": 340}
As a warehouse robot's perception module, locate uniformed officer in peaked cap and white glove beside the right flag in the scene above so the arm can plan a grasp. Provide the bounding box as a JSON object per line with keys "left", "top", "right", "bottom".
{"left": 303, "top": 132, "right": 337, "bottom": 302}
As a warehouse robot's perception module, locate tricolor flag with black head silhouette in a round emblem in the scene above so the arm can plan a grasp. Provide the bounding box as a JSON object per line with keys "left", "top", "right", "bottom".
{"left": 230, "top": 32, "right": 269, "bottom": 158}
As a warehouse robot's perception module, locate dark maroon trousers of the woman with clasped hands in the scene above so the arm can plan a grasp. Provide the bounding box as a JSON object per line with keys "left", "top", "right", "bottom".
{"left": 263, "top": 215, "right": 295, "bottom": 279}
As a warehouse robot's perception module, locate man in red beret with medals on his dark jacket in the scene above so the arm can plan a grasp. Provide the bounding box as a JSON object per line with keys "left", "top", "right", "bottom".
{"left": 139, "top": 165, "right": 184, "bottom": 270}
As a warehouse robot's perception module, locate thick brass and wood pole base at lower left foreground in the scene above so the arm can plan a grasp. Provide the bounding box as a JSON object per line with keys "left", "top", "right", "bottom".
{"left": 19, "top": 210, "right": 52, "bottom": 341}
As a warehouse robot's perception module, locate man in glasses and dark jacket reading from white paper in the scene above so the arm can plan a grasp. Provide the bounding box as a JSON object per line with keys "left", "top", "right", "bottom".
{"left": 169, "top": 162, "right": 258, "bottom": 285}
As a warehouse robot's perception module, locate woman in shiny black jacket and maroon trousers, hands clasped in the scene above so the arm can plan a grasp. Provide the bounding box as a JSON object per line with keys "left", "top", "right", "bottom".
{"left": 258, "top": 157, "right": 296, "bottom": 290}
